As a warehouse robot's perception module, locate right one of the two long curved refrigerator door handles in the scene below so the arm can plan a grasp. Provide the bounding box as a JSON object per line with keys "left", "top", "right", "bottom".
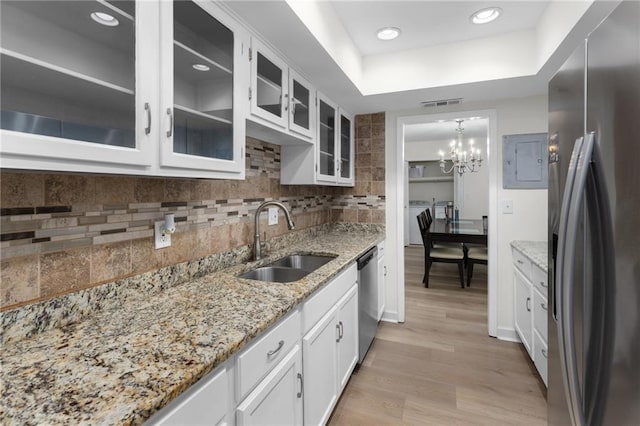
{"left": 560, "top": 133, "right": 595, "bottom": 426}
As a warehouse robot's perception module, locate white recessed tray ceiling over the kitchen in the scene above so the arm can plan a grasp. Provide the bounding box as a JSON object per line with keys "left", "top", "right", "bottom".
{"left": 223, "top": 0, "right": 616, "bottom": 114}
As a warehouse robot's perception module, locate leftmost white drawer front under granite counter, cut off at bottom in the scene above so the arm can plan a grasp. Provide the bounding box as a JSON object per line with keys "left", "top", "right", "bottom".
{"left": 149, "top": 368, "right": 229, "bottom": 426}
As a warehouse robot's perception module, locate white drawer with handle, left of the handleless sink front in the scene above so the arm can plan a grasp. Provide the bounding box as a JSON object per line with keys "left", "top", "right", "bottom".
{"left": 236, "top": 311, "right": 301, "bottom": 400}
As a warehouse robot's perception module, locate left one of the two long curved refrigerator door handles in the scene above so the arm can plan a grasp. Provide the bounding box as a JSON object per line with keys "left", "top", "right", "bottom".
{"left": 553, "top": 137, "right": 584, "bottom": 424}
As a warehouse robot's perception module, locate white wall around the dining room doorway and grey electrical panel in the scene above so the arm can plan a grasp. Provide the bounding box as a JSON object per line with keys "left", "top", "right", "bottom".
{"left": 385, "top": 96, "right": 547, "bottom": 338}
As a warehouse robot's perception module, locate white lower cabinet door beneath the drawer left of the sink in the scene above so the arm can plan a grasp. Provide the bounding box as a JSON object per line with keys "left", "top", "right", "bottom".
{"left": 236, "top": 345, "right": 303, "bottom": 426}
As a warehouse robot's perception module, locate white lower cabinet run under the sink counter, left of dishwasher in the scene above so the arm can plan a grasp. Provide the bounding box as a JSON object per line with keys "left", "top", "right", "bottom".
{"left": 147, "top": 263, "right": 358, "bottom": 426}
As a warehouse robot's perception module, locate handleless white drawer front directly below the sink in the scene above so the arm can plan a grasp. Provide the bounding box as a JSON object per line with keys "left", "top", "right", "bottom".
{"left": 302, "top": 263, "right": 358, "bottom": 334}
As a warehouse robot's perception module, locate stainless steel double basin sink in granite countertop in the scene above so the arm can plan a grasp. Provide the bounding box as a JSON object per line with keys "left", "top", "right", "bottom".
{"left": 238, "top": 254, "right": 336, "bottom": 283}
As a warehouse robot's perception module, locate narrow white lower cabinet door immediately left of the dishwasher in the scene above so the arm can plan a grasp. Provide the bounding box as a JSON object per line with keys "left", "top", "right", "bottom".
{"left": 338, "top": 284, "right": 358, "bottom": 392}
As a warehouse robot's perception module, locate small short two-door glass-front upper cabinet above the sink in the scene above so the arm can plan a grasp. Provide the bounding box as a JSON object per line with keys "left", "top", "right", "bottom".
{"left": 247, "top": 38, "right": 315, "bottom": 145}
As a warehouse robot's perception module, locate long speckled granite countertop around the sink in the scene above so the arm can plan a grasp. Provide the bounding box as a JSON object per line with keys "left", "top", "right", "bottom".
{"left": 0, "top": 231, "right": 384, "bottom": 425}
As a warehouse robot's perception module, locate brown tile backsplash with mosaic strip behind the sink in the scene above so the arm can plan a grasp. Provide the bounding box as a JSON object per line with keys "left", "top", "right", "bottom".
{"left": 0, "top": 113, "right": 385, "bottom": 310}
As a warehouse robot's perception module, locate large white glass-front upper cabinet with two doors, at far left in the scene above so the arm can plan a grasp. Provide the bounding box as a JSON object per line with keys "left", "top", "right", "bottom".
{"left": 0, "top": 0, "right": 244, "bottom": 178}
